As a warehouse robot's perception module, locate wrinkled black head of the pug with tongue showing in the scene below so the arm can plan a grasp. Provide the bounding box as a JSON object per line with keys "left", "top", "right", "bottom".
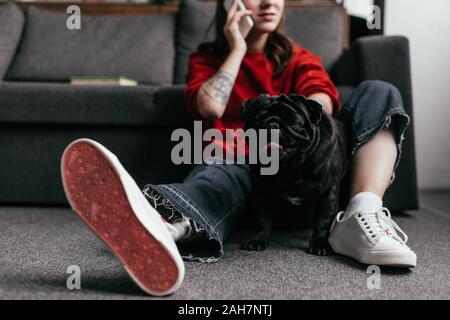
{"left": 241, "top": 94, "right": 323, "bottom": 166}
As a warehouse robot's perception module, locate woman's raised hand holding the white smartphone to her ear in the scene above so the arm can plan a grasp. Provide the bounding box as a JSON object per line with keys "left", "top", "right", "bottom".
{"left": 223, "top": 0, "right": 252, "bottom": 53}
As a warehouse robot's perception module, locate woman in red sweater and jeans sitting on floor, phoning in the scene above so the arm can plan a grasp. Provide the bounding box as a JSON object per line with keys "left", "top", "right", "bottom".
{"left": 62, "top": 0, "right": 416, "bottom": 295}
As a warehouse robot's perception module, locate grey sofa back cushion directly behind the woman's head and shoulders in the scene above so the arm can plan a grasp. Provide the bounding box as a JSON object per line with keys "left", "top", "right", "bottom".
{"left": 174, "top": 0, "right": 345, "bottom": 83}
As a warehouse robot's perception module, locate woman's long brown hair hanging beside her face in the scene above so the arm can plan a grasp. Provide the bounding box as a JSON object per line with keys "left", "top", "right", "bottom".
{"left": 197, "top": 0, "right": 294, "bottom": 75}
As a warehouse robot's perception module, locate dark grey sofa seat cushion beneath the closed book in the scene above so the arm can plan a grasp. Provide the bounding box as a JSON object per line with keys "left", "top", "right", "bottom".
{"left": 0, "top": 81, "right": 189, "bottom": 126}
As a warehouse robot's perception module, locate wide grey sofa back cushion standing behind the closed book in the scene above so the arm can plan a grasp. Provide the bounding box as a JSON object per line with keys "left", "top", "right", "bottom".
{"left": 7, "top": 6, "right": 175, "bottom": 85}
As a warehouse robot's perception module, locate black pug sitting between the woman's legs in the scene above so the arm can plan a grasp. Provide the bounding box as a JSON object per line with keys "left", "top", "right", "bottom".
{"left": 241, "top": 94, "right": 347, "bottom": 255}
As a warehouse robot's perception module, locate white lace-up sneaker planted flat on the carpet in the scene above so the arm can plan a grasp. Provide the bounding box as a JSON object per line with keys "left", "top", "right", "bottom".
{"left": 328, "top": 208, "right": 417, "bottom": 268}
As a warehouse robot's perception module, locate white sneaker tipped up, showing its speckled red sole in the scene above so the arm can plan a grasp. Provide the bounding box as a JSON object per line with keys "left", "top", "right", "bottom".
{"left": 61, "top": 139, "right": 184, "bottom": 296}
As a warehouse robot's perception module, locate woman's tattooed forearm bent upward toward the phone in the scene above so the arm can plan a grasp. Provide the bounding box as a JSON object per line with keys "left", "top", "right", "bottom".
{"left": 197, "top": 49, "right": 245, "bottom": 120}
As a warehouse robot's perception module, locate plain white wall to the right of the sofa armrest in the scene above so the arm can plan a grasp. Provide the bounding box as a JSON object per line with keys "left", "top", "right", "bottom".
{"left": 385, "top": 0, "right": 450, "bottom": 189}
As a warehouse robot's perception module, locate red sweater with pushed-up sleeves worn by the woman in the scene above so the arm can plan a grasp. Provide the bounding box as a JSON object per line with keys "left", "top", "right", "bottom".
{"left": 184, "top": 45, "right": 340, "bottom": 156}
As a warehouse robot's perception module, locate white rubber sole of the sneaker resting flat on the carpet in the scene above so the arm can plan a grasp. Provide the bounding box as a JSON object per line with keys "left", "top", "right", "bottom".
{"left": 328, "top": 239, "right": 417, "bottom": 269}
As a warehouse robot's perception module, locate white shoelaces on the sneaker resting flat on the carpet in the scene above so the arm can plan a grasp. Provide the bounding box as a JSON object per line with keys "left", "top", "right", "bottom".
{"left": 356, "top": 207, "right": 408, "bottom": 244}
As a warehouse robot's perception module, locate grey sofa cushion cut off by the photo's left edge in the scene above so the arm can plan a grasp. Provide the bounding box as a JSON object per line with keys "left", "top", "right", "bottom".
{"left": 0, "top": 2, "right": 24, "bottom": 80}
